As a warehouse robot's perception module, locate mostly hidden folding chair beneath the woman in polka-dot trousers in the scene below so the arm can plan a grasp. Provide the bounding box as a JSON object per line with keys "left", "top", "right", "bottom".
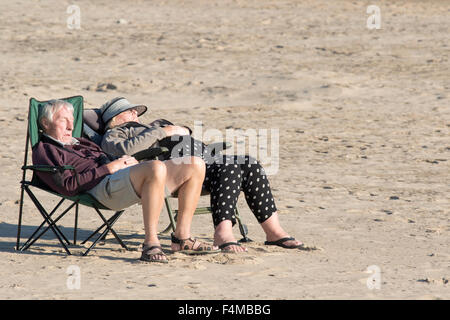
{"left": 83, "top": 108, "right": 251, "bottom": 242}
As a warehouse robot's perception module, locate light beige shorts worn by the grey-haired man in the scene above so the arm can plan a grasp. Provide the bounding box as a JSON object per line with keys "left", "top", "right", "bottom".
{"left": 87, "top": 167, "right": 141, "bottom": 211}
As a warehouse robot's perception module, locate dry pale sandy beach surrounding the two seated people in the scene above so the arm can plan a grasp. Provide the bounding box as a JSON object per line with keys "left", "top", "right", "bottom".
{"left": 0, "top": 0, "right": 450, "bottom": 299}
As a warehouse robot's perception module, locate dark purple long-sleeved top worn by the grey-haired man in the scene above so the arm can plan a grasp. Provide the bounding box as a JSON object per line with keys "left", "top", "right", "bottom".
{"left": 33, "top": 136, "right": 109, "bottom": 196}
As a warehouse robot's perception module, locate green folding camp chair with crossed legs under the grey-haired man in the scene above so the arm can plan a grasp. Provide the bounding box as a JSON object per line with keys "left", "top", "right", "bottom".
{"left": 16, "top": 96, "right": 129, "bottom": 256}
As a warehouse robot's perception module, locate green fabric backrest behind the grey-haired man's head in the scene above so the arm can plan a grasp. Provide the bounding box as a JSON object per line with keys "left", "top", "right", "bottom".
{"left": 27, "top": 96, "right": 83, "bottom": 147}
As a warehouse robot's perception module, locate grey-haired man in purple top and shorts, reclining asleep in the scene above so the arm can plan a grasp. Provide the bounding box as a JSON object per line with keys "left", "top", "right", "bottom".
{"left": 33, "top": 100, "right": 215, "bottom": 263}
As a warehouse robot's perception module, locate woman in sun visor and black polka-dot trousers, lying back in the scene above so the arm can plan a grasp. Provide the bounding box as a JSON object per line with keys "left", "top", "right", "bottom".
{"left": 101, "top": 97, "right": 303, "bottom": 252}
